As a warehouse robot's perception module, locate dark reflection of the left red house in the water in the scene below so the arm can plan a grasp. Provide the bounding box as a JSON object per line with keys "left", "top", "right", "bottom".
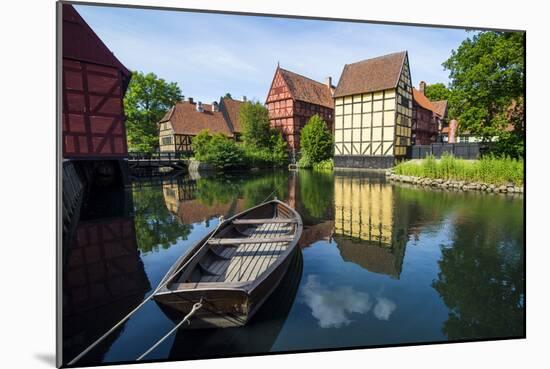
{"left": 63, "top": 190, "right": 151, "bottom": 364}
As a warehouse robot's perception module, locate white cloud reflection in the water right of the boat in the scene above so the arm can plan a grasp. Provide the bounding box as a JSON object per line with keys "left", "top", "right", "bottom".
{"left": 302, "top": 275, "right": 396, "bottom": 328}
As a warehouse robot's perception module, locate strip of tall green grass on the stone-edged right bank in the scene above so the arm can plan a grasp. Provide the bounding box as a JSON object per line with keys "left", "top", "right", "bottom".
{"left": 394, "top": 155, "right": 524, "bottom": 186}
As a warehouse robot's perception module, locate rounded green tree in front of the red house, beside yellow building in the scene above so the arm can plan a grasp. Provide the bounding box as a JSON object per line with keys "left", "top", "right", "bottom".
{"left": 300, "top": 114, "right": 333, "bottom": 164}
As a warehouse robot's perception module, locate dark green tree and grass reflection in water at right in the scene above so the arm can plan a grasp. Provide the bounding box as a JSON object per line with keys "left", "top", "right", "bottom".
{"left": 400, "top": 188, "right": 525, "bottom": 340}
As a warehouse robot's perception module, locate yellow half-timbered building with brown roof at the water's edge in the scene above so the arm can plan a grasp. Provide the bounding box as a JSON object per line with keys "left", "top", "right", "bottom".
{"left": 334, "top": 51, "right": 413, "bottom": 168}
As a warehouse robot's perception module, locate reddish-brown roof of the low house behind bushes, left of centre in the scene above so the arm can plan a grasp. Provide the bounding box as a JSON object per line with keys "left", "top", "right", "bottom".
{"left": 159, "top": 101, "right": 233, "bottom": 136}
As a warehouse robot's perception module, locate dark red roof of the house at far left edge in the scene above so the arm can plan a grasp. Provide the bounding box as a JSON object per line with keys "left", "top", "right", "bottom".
{"left": 63, "top": 4, "right": 131, "bottom": 82}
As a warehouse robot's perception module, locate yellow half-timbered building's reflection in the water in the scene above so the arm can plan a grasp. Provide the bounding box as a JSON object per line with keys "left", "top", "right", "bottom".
{"left": 334, "top": 173, "right": 408, "bottom": 279}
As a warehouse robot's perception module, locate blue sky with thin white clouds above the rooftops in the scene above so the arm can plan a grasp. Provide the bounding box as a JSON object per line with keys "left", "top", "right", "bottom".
{"left": 75, "top": 5, "right": 474, "bottom": 102}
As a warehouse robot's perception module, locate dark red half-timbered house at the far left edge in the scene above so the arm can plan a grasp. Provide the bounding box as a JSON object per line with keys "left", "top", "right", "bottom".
{"left": 61, "top": 4, "right": 131, "bottom": 160}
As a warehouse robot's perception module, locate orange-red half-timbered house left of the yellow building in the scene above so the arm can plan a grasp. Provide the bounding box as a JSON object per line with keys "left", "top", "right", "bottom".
{"left": 266, "top": 65, "right": 334, "bottom": 152}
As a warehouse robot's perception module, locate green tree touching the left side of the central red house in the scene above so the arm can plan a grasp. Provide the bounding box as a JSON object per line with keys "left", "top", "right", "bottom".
{"left": 239, "top": 101, "right": 272, "bottom": 148}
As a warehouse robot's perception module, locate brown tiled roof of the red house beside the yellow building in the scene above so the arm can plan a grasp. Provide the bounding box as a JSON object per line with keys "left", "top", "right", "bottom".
{"left": 278, "top": 68, "right": 334, "bottom": 108}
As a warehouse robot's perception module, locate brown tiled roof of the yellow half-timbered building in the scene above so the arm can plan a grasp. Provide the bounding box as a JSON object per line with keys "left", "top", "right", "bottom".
{"left": 334, "top": 51, "right": 407, "bottom": 97}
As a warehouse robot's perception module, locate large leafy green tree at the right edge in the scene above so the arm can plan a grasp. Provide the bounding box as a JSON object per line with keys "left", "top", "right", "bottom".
{"left": 443, "top": 31, "right": 525, "bottom": 156}
